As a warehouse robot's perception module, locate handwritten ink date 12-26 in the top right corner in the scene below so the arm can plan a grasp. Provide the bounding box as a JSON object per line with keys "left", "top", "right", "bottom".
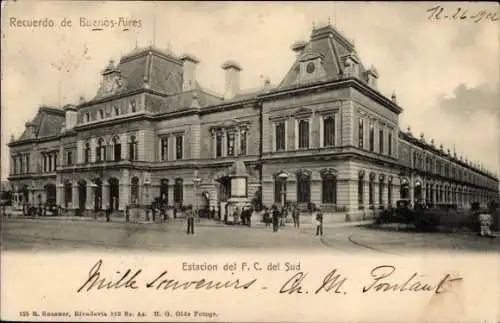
{"left": 426, "top": 5, "right": 499, "bottom": 23}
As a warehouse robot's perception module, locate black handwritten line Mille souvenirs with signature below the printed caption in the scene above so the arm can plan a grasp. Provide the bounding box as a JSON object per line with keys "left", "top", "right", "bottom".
{"left": 77, "top": 260, "right": 463, "bottom": 295}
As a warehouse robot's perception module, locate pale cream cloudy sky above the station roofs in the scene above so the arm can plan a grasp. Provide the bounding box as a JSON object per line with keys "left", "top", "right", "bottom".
{"left": 1, "top": 1, "right": 500, "bottom": 179}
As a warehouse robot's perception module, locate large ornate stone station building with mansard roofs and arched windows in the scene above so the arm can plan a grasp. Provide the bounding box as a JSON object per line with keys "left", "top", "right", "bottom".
{"left": 9, "top": 25, "right": 499, "bottom": 219}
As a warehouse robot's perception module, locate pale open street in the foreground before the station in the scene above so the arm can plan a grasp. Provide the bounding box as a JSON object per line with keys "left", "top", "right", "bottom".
{"left": 1, "top": 218, "right": 500, "bottom": 255}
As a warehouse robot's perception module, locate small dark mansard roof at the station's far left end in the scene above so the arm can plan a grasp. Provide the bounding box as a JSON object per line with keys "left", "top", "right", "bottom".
{"left": 19, "top": 106, "right": 65, "bottom": 140}
